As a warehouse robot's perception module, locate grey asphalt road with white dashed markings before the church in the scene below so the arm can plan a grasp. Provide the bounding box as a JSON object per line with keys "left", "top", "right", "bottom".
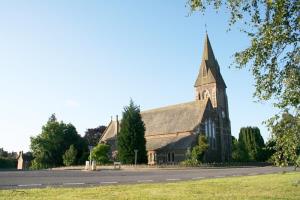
{"left": 0, "top": 166, "right": 293, "bottom": 189}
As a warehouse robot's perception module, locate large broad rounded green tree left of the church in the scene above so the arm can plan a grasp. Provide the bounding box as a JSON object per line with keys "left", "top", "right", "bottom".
{"left": 30, "top": 114, "right": 88, "bottom": 169}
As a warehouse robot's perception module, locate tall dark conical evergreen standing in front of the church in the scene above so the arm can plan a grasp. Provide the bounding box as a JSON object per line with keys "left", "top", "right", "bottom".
{"left": 117, "top": 100, "right": 147, "bottom": 164}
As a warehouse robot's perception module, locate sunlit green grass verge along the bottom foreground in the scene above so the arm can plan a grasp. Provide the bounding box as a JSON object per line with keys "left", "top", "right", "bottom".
{"left": 0, "top": 172, "right": 300, "bottom": 200}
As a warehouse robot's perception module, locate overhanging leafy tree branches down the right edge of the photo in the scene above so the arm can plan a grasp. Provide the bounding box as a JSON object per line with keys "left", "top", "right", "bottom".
{"left": 187, "top": 0, "right": 300, "bottom": 165}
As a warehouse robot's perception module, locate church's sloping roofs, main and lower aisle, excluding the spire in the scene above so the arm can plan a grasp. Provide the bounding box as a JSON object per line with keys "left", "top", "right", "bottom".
{"left": 100, "top": 100, "right": 209, "bottom": 146}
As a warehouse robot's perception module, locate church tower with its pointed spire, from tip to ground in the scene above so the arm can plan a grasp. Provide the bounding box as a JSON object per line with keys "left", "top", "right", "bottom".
{"left": 194, "top": 33, "right": 231, "bottom": 161}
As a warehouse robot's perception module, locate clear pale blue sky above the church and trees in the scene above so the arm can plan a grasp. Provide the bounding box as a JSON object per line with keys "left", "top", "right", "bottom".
{"left": 0, "top": 0, "right": 276, "bottom": 151}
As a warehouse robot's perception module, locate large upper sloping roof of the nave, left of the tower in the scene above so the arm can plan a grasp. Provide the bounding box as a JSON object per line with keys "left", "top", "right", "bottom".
{"left": 141, "top": 100, "right": 207, "bottom": 136}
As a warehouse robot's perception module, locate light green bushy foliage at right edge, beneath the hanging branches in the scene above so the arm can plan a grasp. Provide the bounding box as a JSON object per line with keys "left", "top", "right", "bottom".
{"left": 271, "top": 113, "right": 300, "bottom": 166}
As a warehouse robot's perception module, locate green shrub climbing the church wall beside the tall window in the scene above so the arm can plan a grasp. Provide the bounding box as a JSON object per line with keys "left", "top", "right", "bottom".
{"left": 182, "top": 134, "right": 209, "bottom": 166}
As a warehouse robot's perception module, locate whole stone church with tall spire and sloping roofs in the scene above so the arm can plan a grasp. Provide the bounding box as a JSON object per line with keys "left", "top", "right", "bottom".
{"left": 100, "top": 34, "right": 231, "bottom": 165}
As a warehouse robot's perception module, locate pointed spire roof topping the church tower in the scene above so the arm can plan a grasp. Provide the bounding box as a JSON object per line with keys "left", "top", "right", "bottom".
{"left": 194, "top": 34, "right": 226, "bottom": 87}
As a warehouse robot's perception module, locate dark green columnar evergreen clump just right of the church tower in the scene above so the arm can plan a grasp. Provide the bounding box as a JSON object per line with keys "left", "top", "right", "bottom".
{"left": 239, "top": 127, "right": 265, "bottom": 161}
